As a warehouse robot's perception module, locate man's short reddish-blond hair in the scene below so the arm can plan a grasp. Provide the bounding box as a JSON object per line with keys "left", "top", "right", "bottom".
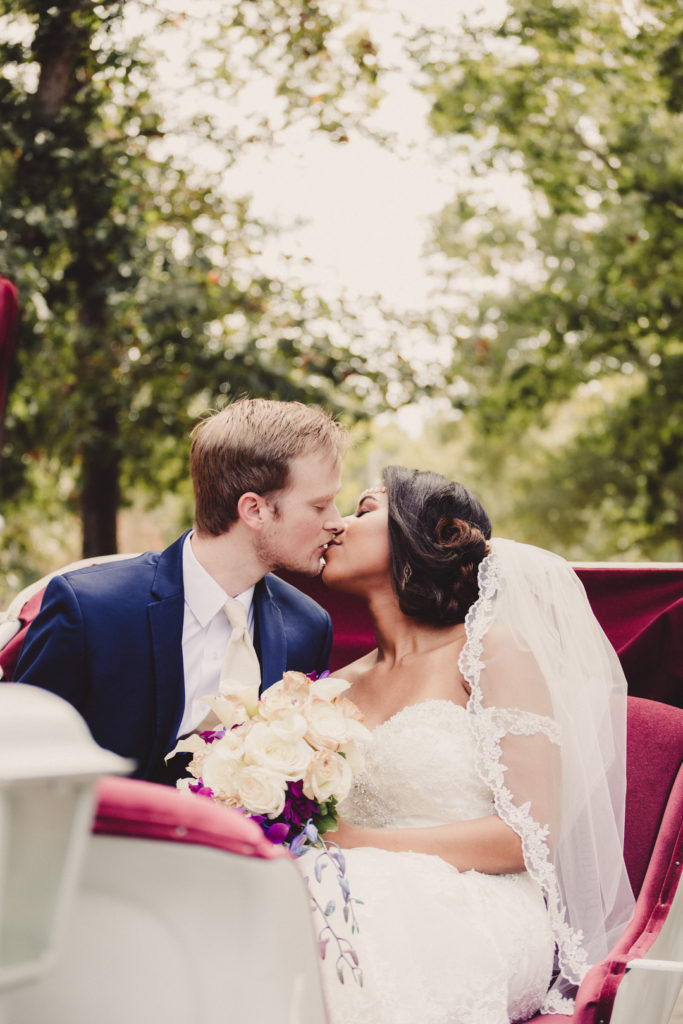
{"left": 189, "top": 398, "right": 347, "bottom": 537}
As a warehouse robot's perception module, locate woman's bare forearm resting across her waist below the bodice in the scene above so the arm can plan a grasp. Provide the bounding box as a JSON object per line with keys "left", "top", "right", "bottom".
{"left": 326, "top": 814, "right": 525, "bottom": 874}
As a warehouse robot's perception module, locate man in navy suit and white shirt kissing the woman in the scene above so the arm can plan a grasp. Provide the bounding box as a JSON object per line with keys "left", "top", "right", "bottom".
{"left": 15, "top": 399, "right": 346, "bottom": 783}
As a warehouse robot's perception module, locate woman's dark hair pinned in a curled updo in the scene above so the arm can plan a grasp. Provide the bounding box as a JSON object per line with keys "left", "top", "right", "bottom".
{"left": 382, "top": 466, "right": 490, "bottom": 626}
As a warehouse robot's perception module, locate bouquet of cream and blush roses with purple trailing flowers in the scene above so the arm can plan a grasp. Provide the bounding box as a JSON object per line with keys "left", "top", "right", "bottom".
{"left": 174, "top": 672, "right": 369, "bottom": 984}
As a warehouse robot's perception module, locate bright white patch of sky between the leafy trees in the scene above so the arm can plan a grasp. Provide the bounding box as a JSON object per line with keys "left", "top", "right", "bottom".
{"left": 124, "top": 0, "right": 507, "bottom": 310}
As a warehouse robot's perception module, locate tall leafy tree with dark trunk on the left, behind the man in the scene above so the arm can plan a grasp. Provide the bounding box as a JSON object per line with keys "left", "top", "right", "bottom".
{"left": 0, "top": 0, "right": 405, "bottom": 556}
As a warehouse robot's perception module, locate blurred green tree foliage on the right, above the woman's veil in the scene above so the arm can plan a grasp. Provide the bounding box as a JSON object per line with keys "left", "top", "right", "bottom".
{"left": 420, "top": 0, "right": 683, "bottom": 557}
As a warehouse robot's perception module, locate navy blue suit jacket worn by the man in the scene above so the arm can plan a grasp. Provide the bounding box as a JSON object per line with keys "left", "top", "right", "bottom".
{"left": 14, "top": 535, "right": 332, "bottom": 781}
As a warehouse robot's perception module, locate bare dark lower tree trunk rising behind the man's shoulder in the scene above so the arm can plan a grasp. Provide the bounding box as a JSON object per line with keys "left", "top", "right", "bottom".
{"left": 81, "top": 409, "right": 120, "bottom": 558}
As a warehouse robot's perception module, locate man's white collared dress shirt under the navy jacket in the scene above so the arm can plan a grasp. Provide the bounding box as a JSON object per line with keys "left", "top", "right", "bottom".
{"left": 178, "top": 534, "right": 254, "bottom": 736}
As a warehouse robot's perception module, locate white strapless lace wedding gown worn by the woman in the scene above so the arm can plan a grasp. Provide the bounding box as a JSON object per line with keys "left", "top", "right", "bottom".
{"left": 299, "top": 700, "right": 554, "bottom": 1024}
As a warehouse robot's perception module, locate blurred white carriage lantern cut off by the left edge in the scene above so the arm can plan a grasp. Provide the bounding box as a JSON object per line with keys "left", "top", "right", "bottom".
{"left": 0, "top": 683, "right": 133, "bottom": 991}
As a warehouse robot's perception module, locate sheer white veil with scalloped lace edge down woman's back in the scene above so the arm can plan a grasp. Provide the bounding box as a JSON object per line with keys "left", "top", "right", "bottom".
{"left": 460, "top": 540, "right": 634, "bottom": 1013}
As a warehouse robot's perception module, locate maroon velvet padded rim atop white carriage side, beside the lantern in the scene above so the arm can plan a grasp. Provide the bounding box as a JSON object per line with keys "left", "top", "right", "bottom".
{"left": 92, "top": 777, "right": 290, "bottom": 860}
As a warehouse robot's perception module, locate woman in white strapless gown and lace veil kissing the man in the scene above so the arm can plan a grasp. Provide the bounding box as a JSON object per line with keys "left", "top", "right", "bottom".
{"left": 303, "top": 467, "right": 633, "bottom": 1024}
